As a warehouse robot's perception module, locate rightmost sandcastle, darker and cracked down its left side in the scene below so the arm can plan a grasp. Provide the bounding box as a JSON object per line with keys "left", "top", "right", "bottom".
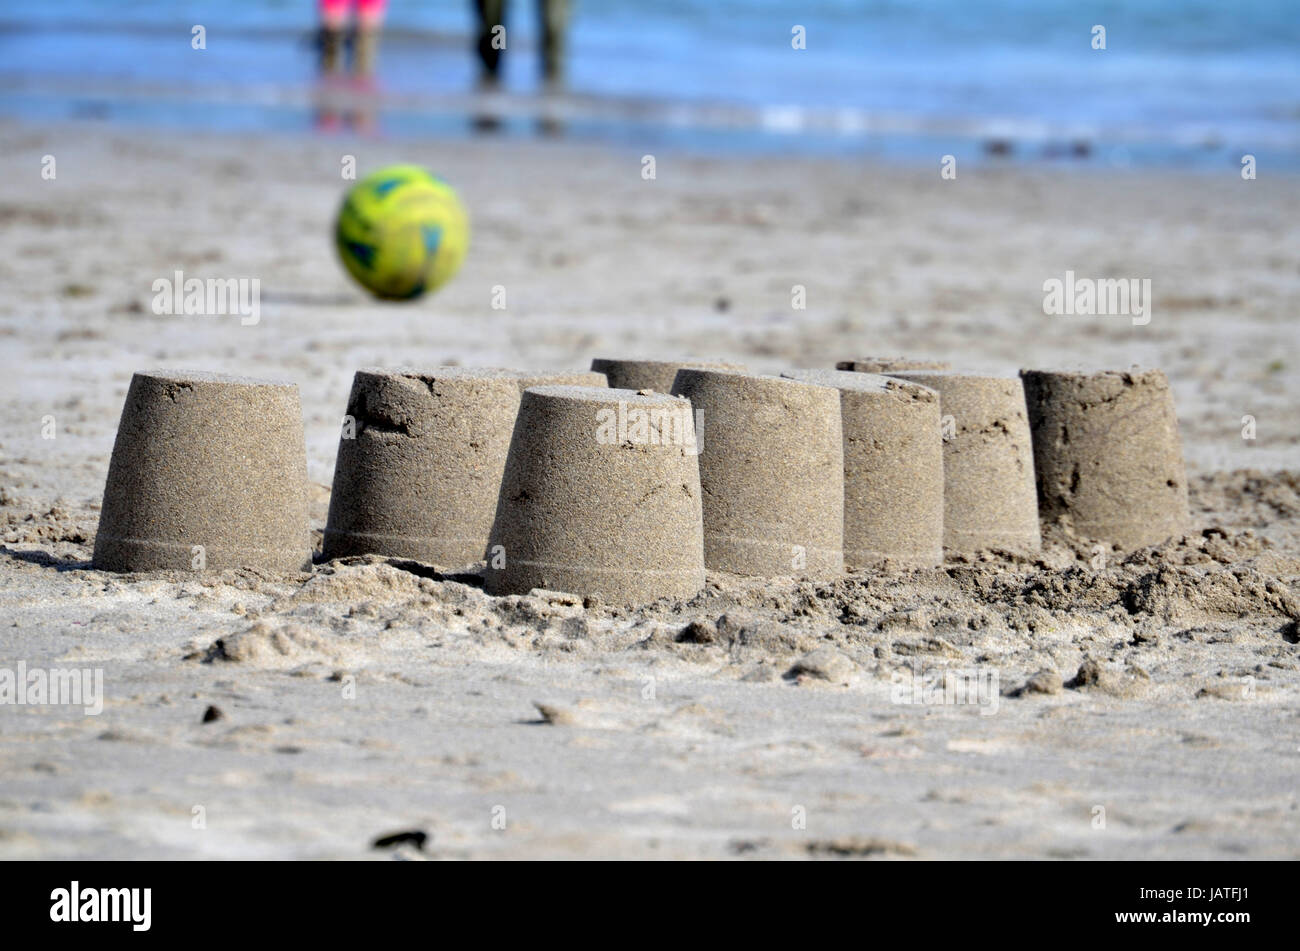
{"left": 1021, "top": 368, "right": 1188, "bottom": 550}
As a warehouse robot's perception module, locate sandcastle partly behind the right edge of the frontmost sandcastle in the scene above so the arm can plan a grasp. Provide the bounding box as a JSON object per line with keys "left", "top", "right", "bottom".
{"left": 672, "top": 369, "right": 844, "bottom": 577}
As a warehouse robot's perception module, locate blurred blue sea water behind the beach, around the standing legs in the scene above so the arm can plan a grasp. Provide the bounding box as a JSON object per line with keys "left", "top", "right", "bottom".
{"left": 0, "top": 0, "right": 1300, "bottom": 168}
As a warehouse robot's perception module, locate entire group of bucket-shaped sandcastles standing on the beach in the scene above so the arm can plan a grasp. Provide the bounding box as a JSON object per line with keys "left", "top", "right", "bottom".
{"left": 94, "top": 360, "right": 1188, "bottom": 604}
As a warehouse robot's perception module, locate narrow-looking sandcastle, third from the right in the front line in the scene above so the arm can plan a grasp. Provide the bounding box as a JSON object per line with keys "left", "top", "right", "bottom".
{"left": 781, "top": 370, "right": 944, "bottom": 568}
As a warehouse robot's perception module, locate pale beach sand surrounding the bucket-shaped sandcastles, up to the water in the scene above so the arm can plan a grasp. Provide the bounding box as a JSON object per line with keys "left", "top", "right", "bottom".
{"left": 0, "top": 123, "right": 1300, "bottom": 857}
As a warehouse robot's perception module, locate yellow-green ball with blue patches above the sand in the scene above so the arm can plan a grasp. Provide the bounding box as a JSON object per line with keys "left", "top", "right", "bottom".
{"left": 334, "top": 165, "right": 469, "bottom": 300}
